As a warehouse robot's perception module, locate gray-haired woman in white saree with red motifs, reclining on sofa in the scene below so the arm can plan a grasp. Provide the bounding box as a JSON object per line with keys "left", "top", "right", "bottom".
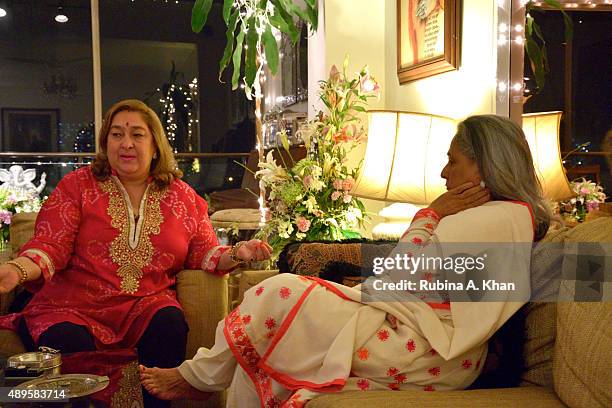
{"left": 141, "top": 115, "right": 550, "bottom": 408}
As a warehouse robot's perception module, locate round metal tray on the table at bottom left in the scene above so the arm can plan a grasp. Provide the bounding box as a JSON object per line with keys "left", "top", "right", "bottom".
{"left": 15, "top": 374, "right": 109, "bottom": 398}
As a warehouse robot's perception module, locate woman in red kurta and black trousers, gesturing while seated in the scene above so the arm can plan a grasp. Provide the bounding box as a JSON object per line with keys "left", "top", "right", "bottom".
{"left": 0, "top": 100, "right": 270, "bottom": 406}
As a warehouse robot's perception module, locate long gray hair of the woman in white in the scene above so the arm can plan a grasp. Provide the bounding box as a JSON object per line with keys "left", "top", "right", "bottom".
{"left": 455, "top": 115, "right": 552, "bottom": 240}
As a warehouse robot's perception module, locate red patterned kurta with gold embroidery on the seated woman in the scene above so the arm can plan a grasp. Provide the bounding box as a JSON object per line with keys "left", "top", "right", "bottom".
{"left": 0, "top": 167, "right": 227, "bottom": 349}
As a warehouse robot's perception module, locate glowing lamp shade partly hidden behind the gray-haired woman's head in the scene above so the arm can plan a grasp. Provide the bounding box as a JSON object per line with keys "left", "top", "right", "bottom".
{"left": 523, "top": 111, "right": 575, "bottom": 201}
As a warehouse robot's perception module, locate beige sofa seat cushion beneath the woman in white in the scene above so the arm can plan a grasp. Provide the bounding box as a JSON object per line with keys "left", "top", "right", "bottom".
{"left": 306, "top": 387, "right": 564, "bottom": 408}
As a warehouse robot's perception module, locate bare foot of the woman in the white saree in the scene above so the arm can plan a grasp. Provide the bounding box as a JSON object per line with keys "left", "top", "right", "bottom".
{"left": 139, "top": 365, "right": 212, "bottom": 400}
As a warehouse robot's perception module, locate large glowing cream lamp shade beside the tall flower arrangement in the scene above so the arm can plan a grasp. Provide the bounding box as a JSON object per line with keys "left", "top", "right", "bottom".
{"left": 352, "top": 111, "right": 457, "bottom": 205}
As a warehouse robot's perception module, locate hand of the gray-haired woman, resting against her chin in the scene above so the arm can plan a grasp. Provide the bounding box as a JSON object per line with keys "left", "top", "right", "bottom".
{"left": 429, "top": 182, "right": 491, "bottom": 218}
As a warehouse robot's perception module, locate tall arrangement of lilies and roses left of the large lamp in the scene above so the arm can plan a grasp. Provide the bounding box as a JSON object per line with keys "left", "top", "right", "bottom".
{"left": 255, "top": 59, "right": 379, "bottom": 253}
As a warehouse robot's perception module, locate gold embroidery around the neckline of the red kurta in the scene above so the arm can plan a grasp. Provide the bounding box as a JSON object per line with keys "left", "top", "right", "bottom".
{"left": 100, "top": 176, "right": 165, "bottom": 293}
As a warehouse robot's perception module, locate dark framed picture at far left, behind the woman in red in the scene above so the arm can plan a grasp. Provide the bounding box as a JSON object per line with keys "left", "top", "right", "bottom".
{"left": 0, "top": 108, "right": 60, "bottom": 152}
